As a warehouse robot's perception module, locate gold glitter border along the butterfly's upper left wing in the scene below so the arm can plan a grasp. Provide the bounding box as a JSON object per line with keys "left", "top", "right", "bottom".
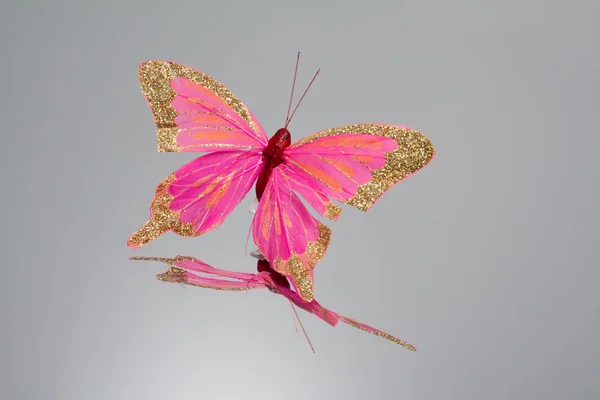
{"left": 138, "top": 61, "right": 261, "bottom": 152}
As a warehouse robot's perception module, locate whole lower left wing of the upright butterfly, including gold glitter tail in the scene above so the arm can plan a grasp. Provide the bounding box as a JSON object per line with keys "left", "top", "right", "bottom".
{"left": 127, "top": 150, "right": 263, "bottom": 248}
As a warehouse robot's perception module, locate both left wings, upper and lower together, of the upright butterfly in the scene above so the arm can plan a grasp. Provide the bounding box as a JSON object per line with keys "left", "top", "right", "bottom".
{"left": 128, "top": 61, "right": 267, "bottom": 248}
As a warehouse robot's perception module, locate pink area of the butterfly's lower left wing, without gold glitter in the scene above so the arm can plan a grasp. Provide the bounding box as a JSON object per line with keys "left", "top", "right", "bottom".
{"left": 169, "top": 151, "right": 262, "bottom": 233}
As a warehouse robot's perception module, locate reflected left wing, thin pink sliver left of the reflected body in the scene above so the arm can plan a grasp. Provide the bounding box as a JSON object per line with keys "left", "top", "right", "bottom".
{"left": 130, "top": 256, "right": 266, "bottom": 291}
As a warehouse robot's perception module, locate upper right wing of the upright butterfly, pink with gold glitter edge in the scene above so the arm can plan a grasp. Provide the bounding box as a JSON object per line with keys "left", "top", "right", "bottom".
{"left": 285, "top": 124, "right": 435, "bottom": 212}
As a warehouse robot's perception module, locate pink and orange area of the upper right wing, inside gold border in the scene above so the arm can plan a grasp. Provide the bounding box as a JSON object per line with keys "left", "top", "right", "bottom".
{"left": 285, "top": 133, "right": 398, "bottom": 203}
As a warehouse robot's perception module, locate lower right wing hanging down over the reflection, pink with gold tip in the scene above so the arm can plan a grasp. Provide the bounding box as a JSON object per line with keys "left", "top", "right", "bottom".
{"left": 252, "top": 168, "right": 331, "bottom": 301}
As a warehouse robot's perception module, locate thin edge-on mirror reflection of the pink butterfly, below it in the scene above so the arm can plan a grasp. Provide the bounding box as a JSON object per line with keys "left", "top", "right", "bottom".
{"left": 131, "top": 256, "right": 417, "bottom": 351}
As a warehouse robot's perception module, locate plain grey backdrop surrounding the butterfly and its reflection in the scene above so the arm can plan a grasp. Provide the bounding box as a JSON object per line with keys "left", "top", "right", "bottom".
{"left": 0, "top": 0, "right": 600, "bottom": 400}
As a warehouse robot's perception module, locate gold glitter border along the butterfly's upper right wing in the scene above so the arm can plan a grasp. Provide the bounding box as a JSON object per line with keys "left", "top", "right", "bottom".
{"left": 298, "top": 124, "right": 435, "bottom": 211}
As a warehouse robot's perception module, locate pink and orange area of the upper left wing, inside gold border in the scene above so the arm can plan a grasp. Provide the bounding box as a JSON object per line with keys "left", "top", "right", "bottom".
{"left": 171, "top": 78, "right": 267, "bottom": 152}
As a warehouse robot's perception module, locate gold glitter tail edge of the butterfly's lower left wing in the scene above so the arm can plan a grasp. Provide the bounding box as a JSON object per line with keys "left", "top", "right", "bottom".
{"left": 127, "top": 174, "right": 200, "bottom": 248}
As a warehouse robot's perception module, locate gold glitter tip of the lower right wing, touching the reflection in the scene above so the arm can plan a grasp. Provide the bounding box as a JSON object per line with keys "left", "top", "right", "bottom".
{"left": 273, "top": 223, "right": 331, "bottom": 302}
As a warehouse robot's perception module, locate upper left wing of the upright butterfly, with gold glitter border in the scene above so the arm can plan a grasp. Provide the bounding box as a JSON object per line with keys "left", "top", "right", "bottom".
{"left": 139, "top": 61, "right": 268, "bottom": 152}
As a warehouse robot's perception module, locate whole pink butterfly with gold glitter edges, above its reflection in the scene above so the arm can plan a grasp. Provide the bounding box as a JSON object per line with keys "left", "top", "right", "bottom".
{"left": 127, "top": 54, "right": 435, "bottom": 301}
